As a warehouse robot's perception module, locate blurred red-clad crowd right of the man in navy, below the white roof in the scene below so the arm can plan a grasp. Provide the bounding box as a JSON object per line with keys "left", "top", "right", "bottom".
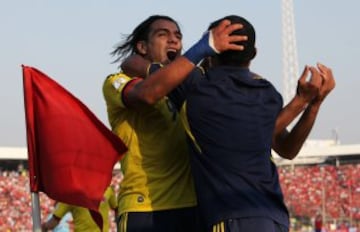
{"left": 279, "top": 163, "right": 360, "bottom": 231}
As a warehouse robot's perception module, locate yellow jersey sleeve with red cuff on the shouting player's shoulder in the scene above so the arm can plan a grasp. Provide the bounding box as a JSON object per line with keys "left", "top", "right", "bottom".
{"left": 103, "top": 73, "right": 140, "bottom": 108}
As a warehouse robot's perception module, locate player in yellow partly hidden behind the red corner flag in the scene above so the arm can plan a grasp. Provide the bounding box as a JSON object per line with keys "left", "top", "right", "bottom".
{"left": 41, "top": 187, "right": 117, "bottom": 232}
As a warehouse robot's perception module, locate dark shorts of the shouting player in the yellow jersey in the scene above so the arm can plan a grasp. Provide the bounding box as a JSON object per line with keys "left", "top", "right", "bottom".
{"left": 117, "top": 207, "right": 200, "bottom": 232}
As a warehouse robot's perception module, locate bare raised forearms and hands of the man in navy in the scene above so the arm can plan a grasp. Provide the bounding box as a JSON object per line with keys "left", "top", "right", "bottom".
{"left": 272, "top": 63, "right": 335, "bottom": 159}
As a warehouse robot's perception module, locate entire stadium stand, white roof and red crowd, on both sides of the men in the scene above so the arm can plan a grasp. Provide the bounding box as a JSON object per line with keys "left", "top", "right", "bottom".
{"left": 0, "top": 141, "right": 360, "bottom": 232}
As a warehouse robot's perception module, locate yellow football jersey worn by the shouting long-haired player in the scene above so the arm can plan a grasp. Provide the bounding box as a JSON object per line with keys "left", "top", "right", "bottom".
{"left": 103, "top": 73, "right": 196, "bottom": 214}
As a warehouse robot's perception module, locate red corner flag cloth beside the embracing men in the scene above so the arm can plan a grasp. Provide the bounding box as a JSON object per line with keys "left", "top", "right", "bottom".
{"left": 22, "top": 66, "right": 127, "bottom": 211}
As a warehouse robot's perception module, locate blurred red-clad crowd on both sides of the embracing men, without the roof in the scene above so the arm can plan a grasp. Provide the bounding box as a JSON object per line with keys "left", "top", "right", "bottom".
{"left": 0, "top": 163, "right": 360, "bottom": 232}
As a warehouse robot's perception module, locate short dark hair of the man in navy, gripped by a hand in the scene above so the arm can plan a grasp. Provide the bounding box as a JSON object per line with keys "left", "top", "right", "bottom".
{"left": 209, "top": 15, "right": 256, "bottom": 66}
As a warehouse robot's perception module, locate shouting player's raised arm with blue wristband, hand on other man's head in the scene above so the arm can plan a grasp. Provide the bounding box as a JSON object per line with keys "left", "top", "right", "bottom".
{"left": 126, "top": 20, "right": 247, "bottom": 106}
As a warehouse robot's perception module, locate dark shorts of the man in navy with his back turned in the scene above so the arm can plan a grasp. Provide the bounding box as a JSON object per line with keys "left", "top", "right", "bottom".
{"left": 208, "top": 217, "right": 289, "bottom": 232}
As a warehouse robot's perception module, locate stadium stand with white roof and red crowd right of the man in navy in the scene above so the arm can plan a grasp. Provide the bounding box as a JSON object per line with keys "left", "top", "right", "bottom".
{"left": 274, "top": 140, "right": 360, "bottom": 231}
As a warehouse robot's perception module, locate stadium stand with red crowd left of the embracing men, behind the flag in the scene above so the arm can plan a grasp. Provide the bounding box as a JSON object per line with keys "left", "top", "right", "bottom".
{"left": 0, "top": 147, "right": 122, "bottom": 232}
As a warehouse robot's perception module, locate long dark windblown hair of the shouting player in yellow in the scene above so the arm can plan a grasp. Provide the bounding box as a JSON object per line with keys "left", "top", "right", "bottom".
{"left": 111, "top": 15, "right": 180, "bottom": 63}
